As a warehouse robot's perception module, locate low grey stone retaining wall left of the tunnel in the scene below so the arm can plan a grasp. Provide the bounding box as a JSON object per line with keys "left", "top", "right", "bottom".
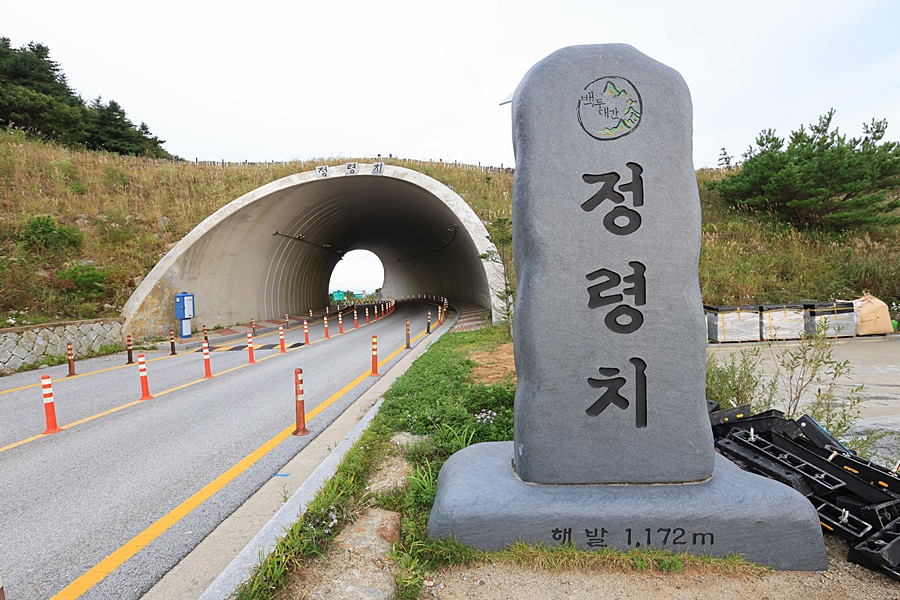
{"left": 0, "top": 319, "right": 124, "bottom": 373}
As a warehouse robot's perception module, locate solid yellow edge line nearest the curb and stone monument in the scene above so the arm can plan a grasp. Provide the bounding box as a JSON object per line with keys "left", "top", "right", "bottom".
{"left": 51, "top": 332, "right": 425, "bottom": 600}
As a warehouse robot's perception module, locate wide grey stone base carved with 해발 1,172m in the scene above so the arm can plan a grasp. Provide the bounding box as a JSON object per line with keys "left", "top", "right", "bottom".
{"left": 428, "top": 442, "right": 828, "bottom": 571}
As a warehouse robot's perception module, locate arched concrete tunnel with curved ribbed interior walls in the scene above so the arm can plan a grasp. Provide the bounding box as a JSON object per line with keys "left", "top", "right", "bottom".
{"left": 122, "top": 163, "right": 503, "bottom": 339}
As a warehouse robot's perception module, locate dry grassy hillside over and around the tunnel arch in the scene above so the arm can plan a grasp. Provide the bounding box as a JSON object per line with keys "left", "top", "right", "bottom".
{"left": 0, "top": 130, "right": 900, "bottom": 325}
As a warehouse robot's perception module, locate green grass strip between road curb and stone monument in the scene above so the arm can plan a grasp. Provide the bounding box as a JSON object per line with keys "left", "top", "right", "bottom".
{"left": 237, "top": 326, "right": 761, "bottom": 599}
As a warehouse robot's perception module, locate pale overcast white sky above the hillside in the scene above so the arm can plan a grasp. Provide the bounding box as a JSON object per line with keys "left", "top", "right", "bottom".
{"left": 7, "top": 0, "right": 900, "bottom": 290}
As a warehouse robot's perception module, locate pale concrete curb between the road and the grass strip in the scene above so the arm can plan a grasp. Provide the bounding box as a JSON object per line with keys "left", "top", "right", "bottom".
{"left": 200, "top": 310, "right": 460, "bottom": 600}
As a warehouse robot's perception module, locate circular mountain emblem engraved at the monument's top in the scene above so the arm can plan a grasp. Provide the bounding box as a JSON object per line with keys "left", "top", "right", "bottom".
{"left": 578, "top": 77, "right": 641, "bottom": 140}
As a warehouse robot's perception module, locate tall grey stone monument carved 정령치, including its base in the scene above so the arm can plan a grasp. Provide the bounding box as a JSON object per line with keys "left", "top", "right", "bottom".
{"left": 429, "top": 44, "right": 827, "bottom": 570}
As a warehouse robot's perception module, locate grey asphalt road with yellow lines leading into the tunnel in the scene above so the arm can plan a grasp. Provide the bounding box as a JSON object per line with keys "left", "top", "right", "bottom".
{"left": 0, "top": 304, "right": 434, "bottom": 600}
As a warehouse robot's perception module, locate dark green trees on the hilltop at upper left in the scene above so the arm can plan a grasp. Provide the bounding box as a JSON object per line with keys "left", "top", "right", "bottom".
{"left": 0, "top": 37, "right": 173, "bottom": 158}
